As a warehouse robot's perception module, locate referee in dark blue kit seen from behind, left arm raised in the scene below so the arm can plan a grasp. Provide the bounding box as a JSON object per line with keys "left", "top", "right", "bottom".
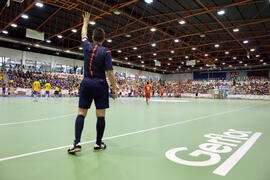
{"left": 68, "top": 13, "right": 117, "bottom": 154}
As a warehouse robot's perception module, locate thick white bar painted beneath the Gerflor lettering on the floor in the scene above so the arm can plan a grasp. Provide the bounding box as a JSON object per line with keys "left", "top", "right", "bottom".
{"left": 213, "top": 132, "right": 262, "bottom": 176}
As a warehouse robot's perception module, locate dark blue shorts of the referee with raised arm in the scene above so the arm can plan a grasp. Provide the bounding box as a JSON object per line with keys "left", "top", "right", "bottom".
{"left": 79, "top": 78, "right": 109, "bottom": 109}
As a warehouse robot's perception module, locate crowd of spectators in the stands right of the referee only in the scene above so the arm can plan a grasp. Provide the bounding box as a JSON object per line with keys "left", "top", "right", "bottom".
{"left": 114, "top": 77, "right": 270, "bottom": 97}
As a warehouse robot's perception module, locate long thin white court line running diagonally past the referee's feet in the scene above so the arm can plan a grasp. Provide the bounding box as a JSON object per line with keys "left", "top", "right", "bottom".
{"left": 0, "top": 106, "right": 254, "bottom": 162}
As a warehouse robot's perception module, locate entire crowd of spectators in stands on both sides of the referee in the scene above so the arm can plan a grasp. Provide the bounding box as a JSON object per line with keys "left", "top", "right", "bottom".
{"left": 0, "top": 69, "right": 270, "bottom": 97}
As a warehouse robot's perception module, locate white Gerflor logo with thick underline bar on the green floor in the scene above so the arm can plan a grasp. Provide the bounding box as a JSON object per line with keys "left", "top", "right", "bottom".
{"left": 165, "top": 129, "right": 262, "bottom": 176}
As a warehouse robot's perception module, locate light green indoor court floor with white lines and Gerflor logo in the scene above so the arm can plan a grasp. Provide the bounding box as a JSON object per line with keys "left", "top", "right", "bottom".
{"left": 0, "top": 98, "right": 270, "bottom": 180}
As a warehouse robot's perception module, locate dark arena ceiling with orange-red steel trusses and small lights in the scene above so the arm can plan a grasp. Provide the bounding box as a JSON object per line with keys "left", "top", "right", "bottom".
{"left": 0, "top": 0, "right": 270, "bottom": 73}
